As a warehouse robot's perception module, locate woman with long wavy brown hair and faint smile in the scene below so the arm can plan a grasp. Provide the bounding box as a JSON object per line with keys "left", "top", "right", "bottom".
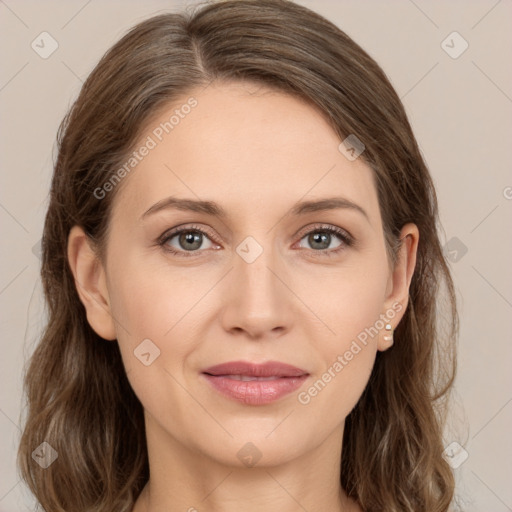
{"left": 19, "top": 0, "right": 458, "bottom": 512}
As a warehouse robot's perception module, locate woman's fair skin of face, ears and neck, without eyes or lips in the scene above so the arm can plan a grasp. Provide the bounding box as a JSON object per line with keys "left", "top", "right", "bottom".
{"left": 68, "top": 82, "right": 419, "bottom": 512}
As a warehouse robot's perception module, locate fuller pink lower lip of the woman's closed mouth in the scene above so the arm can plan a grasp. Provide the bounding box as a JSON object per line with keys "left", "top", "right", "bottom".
{"left": 203, "top": 373, "right": 308, "bottom": 405}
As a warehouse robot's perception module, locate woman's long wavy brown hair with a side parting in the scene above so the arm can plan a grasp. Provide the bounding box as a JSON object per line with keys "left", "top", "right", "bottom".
{"left": 17, "top": 0, "right": 459, "bottom": 512}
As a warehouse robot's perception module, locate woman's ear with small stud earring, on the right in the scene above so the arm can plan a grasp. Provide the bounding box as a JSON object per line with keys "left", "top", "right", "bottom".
{"left": 377, "top": 223, "right": 420, "bottom": 351}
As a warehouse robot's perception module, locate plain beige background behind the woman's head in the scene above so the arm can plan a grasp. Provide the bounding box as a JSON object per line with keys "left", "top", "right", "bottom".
{"left": 0, "top": 0, "right": 512, "bottom": 512}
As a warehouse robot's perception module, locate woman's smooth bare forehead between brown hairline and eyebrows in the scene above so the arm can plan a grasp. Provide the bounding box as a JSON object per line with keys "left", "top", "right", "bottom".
{"left": 109, "top": 82, "right": 379, "bottom": 224}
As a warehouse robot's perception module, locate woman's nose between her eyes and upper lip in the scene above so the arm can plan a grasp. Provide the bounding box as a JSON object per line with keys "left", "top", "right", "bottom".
{"left": 222, "top": 237, "right": 297, "bottom": 339}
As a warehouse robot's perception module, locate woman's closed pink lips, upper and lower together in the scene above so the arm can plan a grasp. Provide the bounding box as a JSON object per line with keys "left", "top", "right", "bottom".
{"left": 202, "top": 361, "right": 309, "bottom": 405}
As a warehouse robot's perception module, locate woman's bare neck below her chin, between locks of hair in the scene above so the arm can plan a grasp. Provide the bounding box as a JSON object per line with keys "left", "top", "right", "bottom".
{"left": 133, "top": 412, "right": 361, "bottom": 512}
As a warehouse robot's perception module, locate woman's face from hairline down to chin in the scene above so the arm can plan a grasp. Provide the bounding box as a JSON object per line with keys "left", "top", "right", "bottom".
{"left": 73, "top": 83, "right": 417, "bottom": 466}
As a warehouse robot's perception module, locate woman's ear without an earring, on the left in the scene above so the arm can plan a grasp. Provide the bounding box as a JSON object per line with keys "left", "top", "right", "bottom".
{"left": 68, "top": 226, "right": 117, "bottom": 340}
